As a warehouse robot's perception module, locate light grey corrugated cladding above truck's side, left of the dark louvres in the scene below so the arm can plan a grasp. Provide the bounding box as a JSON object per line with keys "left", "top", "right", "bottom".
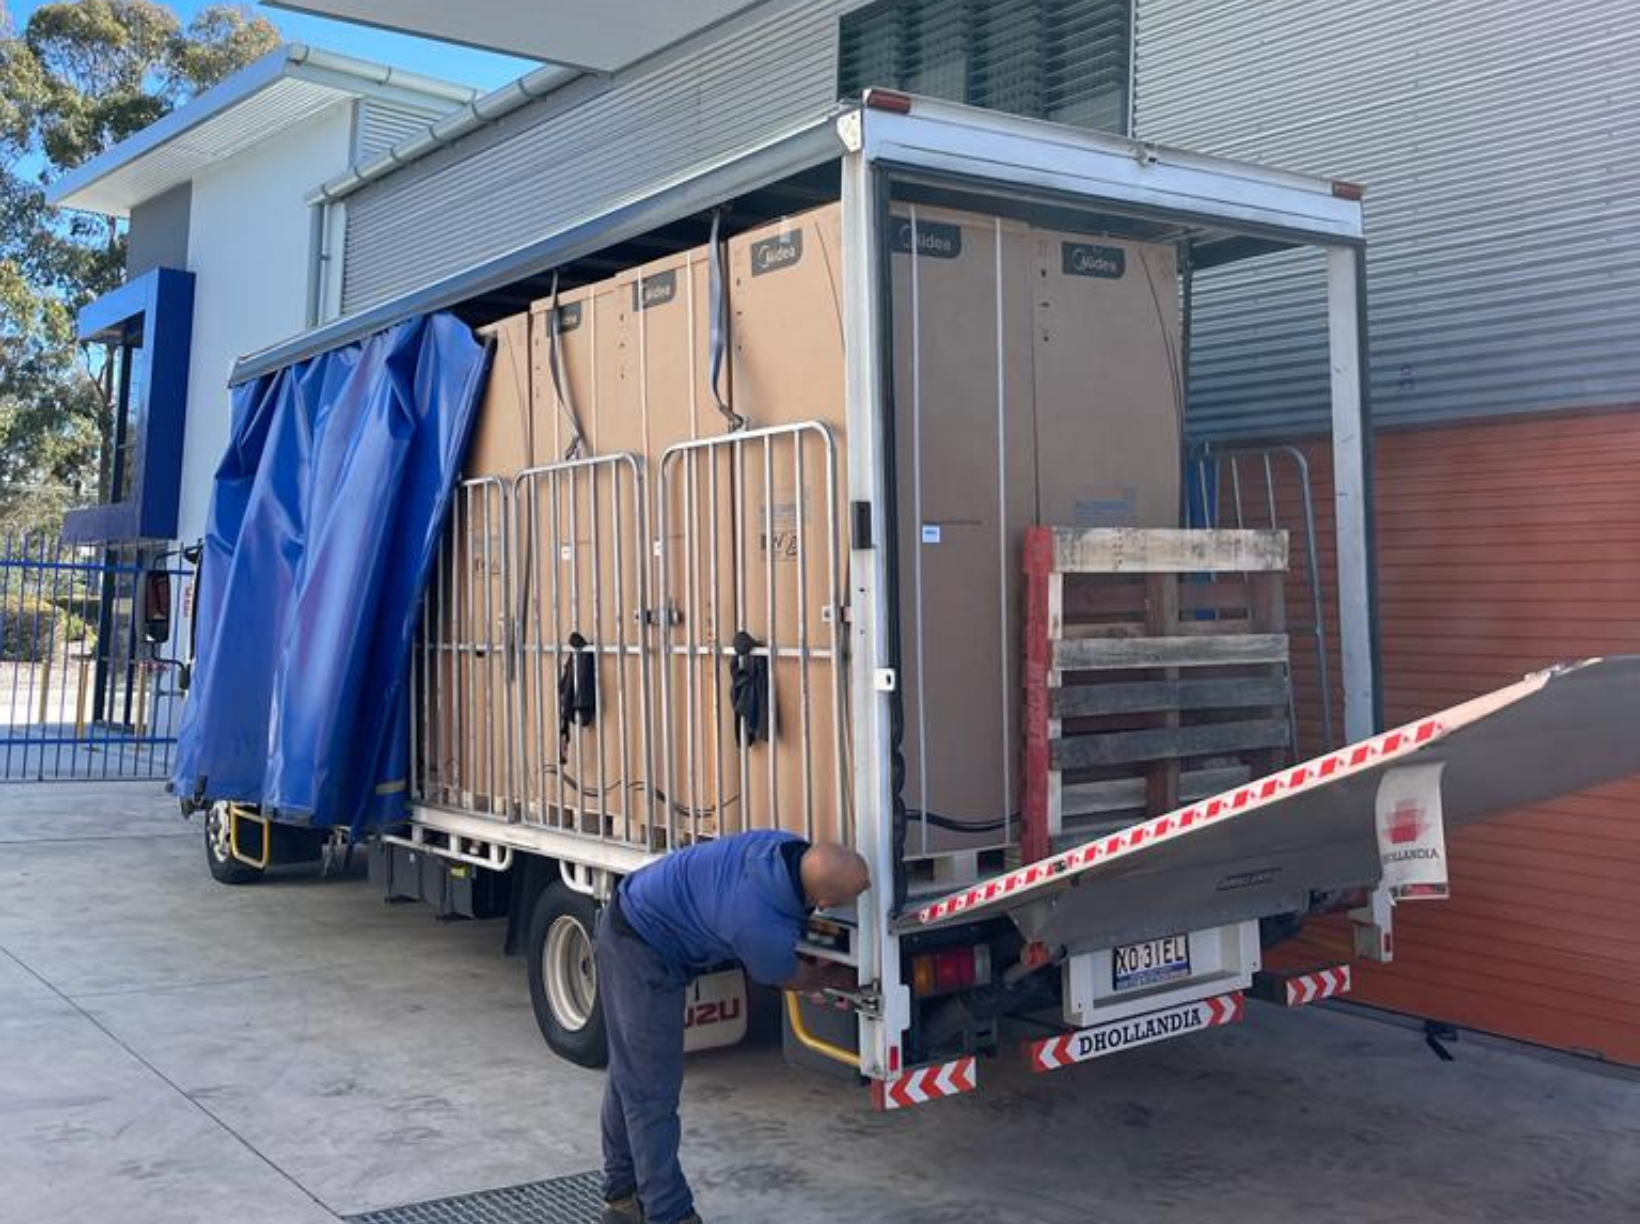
{"left": 343, "top": 0, "right": 858, "bottom": 313}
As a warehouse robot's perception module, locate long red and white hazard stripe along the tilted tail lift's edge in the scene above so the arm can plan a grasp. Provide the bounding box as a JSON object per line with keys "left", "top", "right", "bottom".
{"left": 917, "top": 719, "right": 1448, "bottom": 924}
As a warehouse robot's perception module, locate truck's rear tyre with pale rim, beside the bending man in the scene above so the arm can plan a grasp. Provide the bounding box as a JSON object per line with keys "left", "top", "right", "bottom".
{"left": 526, "top": 879, "right": 608, "bottom": 1066}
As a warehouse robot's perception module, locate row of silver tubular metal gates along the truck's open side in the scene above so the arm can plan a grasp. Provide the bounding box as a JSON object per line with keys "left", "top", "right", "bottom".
{"left": 412, "top": 423, "right": 853, "bottom": 850}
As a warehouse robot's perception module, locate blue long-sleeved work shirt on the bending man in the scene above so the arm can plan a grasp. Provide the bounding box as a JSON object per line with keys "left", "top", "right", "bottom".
{"left": 620, "top": 832, "right": 809, "bottom": 986}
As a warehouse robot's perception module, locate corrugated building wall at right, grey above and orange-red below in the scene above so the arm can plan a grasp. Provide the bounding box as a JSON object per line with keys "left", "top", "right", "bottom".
{"left": 1135, "top": 0, "right": 1640, "bottom": 1063}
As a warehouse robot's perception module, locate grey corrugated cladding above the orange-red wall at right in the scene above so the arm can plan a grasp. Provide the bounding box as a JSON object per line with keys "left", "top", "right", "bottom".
{"left": 1135, "top": 0, "right": 1640, "bottom": 436}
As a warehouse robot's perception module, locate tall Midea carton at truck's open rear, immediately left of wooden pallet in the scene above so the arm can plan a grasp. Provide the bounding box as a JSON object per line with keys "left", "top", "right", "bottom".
{"left": 889, "top": 207, "right": 1038, "bottom": 856}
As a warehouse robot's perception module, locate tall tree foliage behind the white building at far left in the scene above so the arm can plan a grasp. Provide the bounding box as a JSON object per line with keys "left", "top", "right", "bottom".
{"left": 0, "top": 0, "right": 279, "bottom": 533}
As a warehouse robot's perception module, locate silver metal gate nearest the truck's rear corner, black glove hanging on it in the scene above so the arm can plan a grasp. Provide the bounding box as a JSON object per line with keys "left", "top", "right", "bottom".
{"left": 658, "top": 422, "right": 853, "bottom": 845}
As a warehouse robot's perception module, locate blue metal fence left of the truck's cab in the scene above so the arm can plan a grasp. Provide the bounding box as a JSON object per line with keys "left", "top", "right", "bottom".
{"left": 0, "top": 535, "right": 194, "bottom": 783}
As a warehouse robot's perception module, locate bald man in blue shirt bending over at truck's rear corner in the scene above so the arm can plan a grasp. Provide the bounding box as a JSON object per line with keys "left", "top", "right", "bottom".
{"left": 595, "top": 832, "right": 871, "bottom": 1224}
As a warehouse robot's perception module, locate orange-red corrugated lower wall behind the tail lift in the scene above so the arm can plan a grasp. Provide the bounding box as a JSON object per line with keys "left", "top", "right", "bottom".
{"left": 1271, "top": 404, "right": 1640, "bottom": 1065}
